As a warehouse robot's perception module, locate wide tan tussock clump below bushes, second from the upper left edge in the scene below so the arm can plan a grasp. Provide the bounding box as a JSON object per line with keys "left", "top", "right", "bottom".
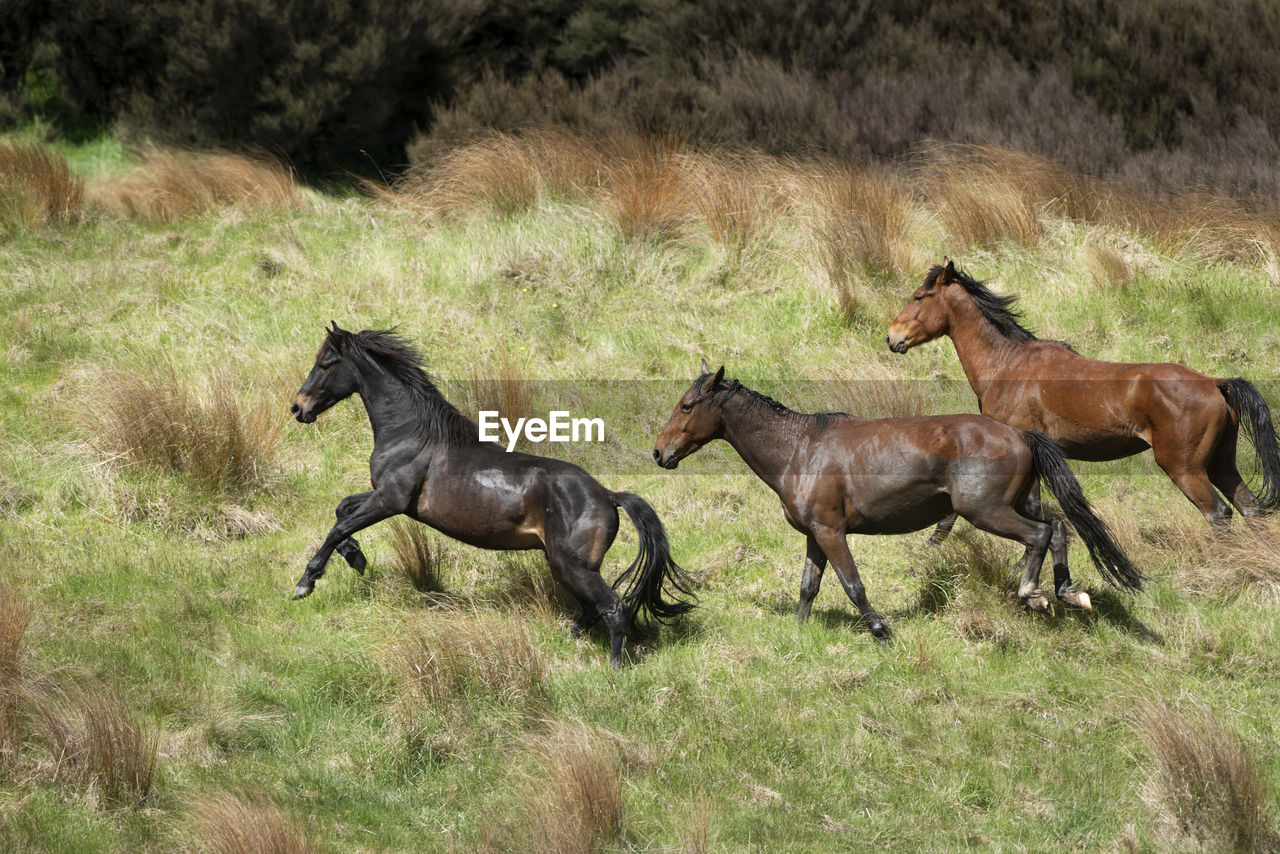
{"left": 90, "top": 147, "right": 302, "bottom": 224}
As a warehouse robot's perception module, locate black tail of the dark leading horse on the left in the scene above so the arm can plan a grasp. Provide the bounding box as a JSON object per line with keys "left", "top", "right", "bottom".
{"left": 612, "top": 492, "right": 694, "bottom": 636}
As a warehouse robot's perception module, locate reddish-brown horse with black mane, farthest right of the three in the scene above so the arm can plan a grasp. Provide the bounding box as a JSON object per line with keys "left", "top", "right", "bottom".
{"left": 886, "top": 259, "right": 1280, "bottom": 550}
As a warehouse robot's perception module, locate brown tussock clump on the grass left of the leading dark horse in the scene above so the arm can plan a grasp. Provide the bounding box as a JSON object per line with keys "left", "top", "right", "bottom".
{"left": 92, "top": 369, "right": 282, "bottom": 489}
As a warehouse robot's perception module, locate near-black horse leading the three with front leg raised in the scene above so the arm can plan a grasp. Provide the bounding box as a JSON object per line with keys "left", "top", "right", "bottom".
{"left": 291, "top": 323, "right": 694, "bottom": 667}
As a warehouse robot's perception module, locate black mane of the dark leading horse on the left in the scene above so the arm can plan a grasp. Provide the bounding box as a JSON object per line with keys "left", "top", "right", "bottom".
{"left": 329, "top": 329, "right": 479, "bottom": 444}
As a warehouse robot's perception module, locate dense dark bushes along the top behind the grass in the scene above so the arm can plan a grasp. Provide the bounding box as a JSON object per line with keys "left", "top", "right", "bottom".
{"left": 0, "top": 0, "right": 1280, "bottom": 195}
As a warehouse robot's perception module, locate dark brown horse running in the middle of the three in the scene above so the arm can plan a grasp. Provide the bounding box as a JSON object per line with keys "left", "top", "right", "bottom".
{"left": 653, "top": 361, "right": 1143, "bottom": 638}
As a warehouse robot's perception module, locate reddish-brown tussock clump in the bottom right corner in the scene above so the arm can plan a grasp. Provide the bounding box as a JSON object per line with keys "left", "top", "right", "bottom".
{"left": 1137, "top": 700, "right": 1280, "bottom": 851}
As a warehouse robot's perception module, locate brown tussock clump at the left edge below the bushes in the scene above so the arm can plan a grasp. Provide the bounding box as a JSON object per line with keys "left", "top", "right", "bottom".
{"left": 0, "top": 142, "right": 84, "bottom": 232}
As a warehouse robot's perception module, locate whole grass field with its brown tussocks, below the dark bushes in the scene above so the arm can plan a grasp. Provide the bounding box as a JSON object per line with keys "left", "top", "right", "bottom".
{"left": 0, "top": 130, "right": 1280, "bottom": 851}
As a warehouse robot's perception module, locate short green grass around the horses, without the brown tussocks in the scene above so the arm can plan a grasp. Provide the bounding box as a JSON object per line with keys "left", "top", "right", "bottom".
{"left": 0, "top": 141, "right": 1280, "bottom": 851}
